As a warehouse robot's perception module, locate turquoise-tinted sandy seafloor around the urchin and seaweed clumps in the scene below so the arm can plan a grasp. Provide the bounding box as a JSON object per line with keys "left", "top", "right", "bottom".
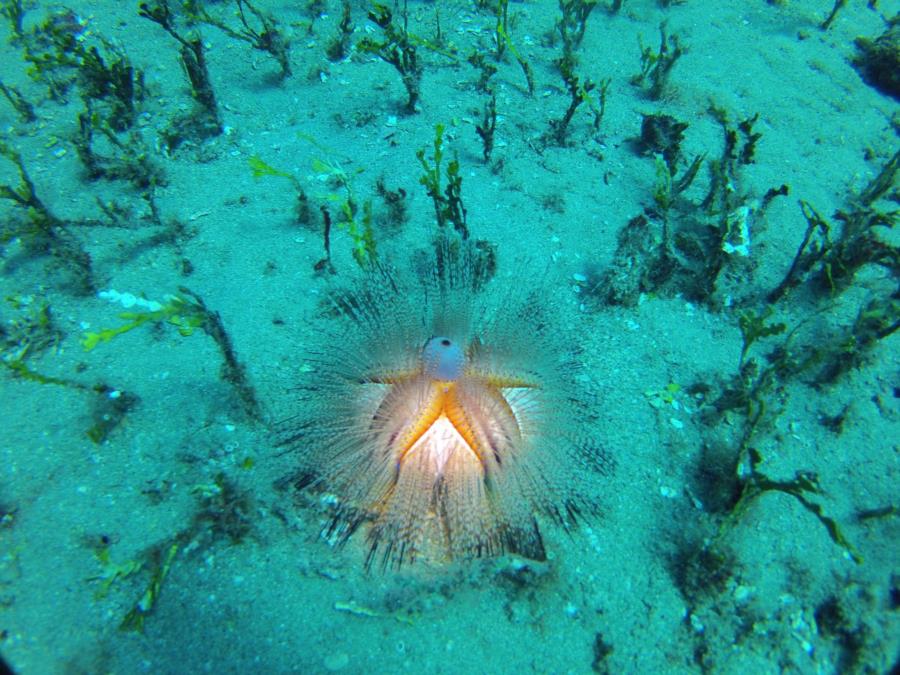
{"left": 0, "top": 0, "right": 900, "bottom": 673}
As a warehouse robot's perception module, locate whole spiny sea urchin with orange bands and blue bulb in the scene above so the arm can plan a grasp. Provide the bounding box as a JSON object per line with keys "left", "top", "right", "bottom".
{"left": 279, "top": 240, "right": 610, "bottom": 566}
